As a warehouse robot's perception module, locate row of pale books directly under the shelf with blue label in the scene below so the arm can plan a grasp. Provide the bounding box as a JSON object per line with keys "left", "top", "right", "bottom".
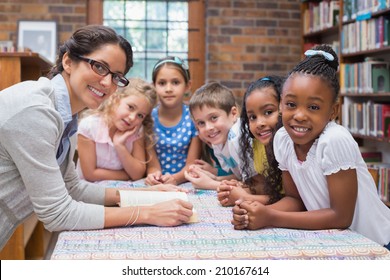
{"left": 340, "top": 16, "right": 390, "bottom": 54}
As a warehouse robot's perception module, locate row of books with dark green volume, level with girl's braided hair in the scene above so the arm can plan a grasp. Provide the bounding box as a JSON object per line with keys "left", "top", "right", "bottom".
{"left": 340, "top": 58, "right": 390, "bottom": 94}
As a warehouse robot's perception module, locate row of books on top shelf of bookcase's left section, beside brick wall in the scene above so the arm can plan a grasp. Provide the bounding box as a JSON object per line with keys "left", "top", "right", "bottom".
{"left": 303, "top": 1, "right": 340, "bottom": 34}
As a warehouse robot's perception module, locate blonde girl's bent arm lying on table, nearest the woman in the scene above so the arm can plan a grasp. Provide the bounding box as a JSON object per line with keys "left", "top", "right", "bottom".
{"left": 77, "top": 134, "right": 130, "bottom": 182}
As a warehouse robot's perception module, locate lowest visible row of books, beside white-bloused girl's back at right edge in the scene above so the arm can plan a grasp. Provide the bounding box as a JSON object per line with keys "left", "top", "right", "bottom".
{"left": 367, "top": 163, "right": 390, "bottom": 203}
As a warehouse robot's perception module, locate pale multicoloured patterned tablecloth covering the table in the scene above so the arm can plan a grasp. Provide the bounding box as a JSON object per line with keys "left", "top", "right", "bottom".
{"left": 52, "top": 182, "right": 390, "bottom": 260}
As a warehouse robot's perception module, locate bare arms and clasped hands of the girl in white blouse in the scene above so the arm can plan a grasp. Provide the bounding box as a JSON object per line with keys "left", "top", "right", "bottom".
{"left": 232, "top": 169, "right": 357, "bottom": 229}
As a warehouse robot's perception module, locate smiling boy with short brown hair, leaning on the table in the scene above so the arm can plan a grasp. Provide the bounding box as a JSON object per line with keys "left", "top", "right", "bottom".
{"left": 186, "top": 82, "right": 251, "bottom": 190}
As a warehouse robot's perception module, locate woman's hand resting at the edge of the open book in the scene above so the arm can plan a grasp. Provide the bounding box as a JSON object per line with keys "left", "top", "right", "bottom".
{"left": 141, "top": 199, "right": 193, "bottom": 227}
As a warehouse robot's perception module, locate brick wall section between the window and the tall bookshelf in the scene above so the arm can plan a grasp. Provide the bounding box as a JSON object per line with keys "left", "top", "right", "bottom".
{"left": 206, "top": 0, "right": 301, "bottom": 97}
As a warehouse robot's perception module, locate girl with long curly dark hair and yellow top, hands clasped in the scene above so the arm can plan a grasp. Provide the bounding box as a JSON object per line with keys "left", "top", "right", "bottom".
{"left": 218, "top": 76, "right": 283, "bottom": 206}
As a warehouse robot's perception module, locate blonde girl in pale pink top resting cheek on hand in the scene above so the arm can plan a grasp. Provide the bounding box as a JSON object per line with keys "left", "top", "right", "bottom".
{"left": 77, "top": 78, "right": 157, "bottom": 182}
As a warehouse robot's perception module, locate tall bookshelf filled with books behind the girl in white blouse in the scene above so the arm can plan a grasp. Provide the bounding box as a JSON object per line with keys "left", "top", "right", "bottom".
{"left": 301, "top": 0, "right": 390, "bottom": 207}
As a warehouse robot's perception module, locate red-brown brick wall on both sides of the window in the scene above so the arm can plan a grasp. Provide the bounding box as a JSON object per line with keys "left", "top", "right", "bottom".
{"left": 0, "top": 0, "right": 301, "bottom": 97}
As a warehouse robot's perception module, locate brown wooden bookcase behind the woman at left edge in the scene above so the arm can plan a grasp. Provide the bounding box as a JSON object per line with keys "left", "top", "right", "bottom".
{"left": 0, "top": 52, "right": 52, "bottom": 260}
